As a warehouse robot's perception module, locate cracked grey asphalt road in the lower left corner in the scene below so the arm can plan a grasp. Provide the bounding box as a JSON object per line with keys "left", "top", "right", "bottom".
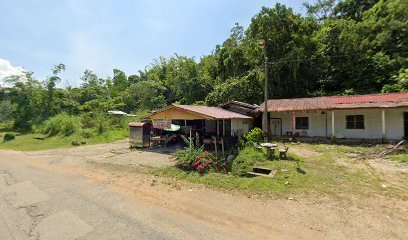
{"left": 0, "top": 155, "right": 236, "bottom": 240}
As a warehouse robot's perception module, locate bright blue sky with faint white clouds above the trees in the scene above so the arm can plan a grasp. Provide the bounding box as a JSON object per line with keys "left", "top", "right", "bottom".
{"left": 0, "top": 0, "right": 312, "bottom": 86}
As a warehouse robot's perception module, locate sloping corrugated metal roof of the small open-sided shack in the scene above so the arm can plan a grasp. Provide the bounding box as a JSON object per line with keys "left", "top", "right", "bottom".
{"left": 173, "top": 105, "right": 252, "bottom": 119}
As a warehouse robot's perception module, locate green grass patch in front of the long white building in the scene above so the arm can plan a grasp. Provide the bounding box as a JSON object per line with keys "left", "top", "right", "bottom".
{"left": 151, "top": 144, "right": 379, "bottom": 197}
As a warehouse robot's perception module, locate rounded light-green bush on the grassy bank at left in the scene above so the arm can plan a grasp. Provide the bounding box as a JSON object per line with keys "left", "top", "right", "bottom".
{"left": 42, "top": 113, "right": 79, "bottom": 136}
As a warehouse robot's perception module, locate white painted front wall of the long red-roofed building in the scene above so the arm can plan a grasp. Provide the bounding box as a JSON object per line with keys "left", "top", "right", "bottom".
{"left": 270, "top": 108, "right": 408, "bottom": 140}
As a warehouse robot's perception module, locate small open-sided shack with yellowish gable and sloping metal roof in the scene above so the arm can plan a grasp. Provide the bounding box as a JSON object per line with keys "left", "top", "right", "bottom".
{"left": 144, "top": 105, "right": 253, "bottom": 157}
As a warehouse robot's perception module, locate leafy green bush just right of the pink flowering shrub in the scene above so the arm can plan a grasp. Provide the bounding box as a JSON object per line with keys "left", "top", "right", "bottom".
{"left": 231, "top": 147, "right": 267, "bottom": 176}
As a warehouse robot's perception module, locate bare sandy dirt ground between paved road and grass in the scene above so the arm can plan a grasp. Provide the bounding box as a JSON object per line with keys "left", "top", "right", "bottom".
{"left": 0, "top": 141, "right": 408, "bottom": 239}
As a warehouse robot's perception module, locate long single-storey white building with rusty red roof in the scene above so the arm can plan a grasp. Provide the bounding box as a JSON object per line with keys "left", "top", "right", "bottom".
{"left": 258, "top": 92, "right": 408, "bottom": 140}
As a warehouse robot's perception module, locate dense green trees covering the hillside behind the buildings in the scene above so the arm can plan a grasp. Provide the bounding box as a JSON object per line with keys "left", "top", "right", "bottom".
{"left": 0, "top": 0, "right": 408, "bottom": 132}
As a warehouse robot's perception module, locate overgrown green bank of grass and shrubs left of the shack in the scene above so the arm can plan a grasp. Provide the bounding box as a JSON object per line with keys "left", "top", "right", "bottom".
{"left": 0, "top": 112, "right": 150, "bottom": 151}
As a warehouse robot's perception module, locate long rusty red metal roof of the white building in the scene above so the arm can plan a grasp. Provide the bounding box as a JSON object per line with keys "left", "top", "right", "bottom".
{"left": 258, "top": 92, "right": 408, "bottom": 112}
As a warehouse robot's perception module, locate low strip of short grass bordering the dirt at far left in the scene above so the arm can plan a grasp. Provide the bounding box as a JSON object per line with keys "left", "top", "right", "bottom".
{"left": 0, "top": 128, "right": 129, "bottom": 151}
